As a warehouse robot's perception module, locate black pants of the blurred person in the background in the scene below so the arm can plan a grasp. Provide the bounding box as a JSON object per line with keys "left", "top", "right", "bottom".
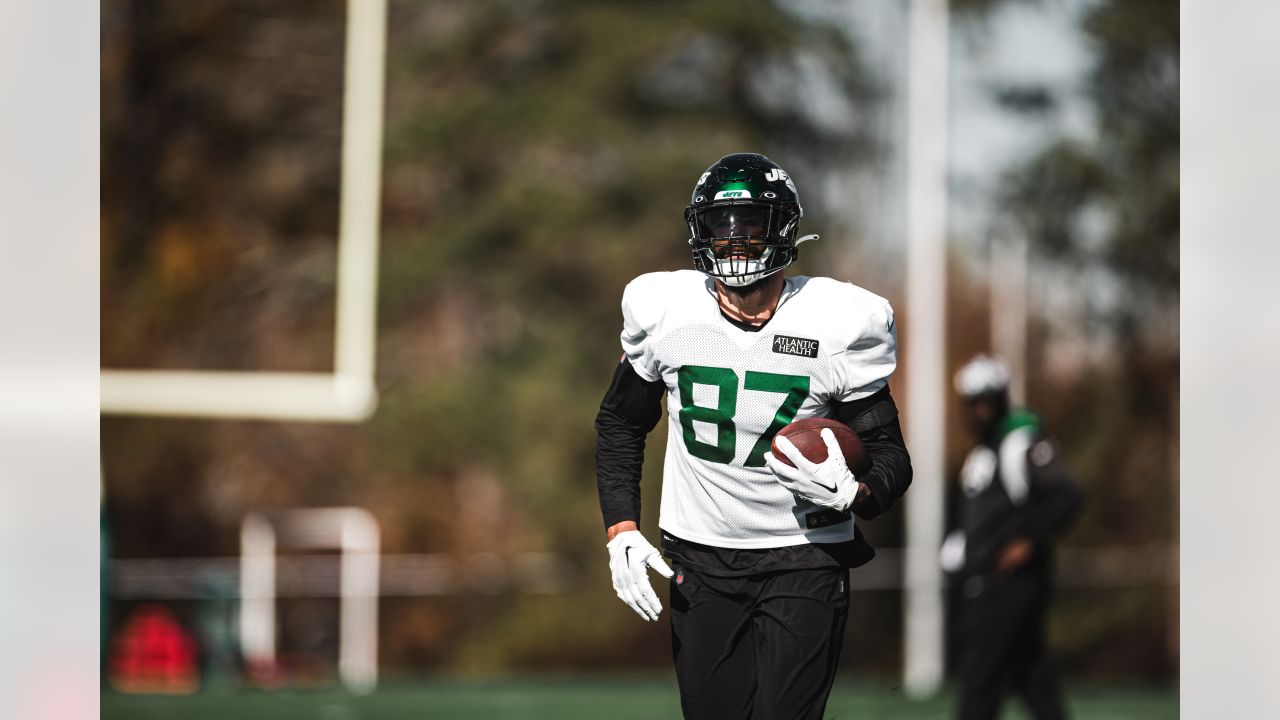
{"left": 957, "top": 568, "right": 1066, "bottom": 720}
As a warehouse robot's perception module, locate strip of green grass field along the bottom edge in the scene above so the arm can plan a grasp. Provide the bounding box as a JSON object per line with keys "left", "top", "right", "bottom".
{"left": 101, "top": 679, "right": 1178, "bottom": 720}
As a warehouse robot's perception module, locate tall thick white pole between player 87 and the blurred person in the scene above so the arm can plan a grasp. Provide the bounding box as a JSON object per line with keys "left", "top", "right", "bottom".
{"left": 902, "top": 0, "right": 947, "bottom": 697}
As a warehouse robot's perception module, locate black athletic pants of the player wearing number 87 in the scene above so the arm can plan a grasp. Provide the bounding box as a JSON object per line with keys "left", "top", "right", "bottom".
{"left": 671, "top": 564, "right": 849, "bottom": 720}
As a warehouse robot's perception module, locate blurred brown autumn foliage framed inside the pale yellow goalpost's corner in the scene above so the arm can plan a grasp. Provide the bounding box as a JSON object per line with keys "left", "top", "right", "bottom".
{"left": 101, "top": 0, "right": 344, "bottom": 370}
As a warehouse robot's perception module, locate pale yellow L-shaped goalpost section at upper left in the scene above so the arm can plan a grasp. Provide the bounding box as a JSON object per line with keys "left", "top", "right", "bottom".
{"left": 100, "top": 0, "right": 387, "bottom": 423}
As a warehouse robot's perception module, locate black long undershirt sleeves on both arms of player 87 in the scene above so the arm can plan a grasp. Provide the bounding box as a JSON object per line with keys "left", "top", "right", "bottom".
{"left": 595, "top": 360, "right": 911, "bottom": 528}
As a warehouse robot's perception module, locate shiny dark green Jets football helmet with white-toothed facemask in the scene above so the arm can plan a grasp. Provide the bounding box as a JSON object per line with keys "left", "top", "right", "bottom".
{"left": 685, "top": 152, "right": 818, "bottom": 287}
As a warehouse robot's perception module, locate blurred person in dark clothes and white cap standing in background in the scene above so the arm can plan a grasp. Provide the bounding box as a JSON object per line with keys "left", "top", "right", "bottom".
{"left": 941, "top": 355, "right": 1083, "bottom": 720}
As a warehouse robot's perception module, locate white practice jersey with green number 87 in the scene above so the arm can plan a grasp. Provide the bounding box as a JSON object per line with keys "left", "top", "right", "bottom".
{"left": 622, "top": 270, "right": 897, "bottom": 548}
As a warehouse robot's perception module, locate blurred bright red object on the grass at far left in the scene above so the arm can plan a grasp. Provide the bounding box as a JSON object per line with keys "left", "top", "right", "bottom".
{"left": 109, "top": 605, "right": 200, "bottom": 694}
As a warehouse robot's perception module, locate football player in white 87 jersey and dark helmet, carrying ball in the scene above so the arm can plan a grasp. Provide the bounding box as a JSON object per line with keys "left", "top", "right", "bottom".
{"left": 595, "top": 152, "right": 911, "bottom": 719}
